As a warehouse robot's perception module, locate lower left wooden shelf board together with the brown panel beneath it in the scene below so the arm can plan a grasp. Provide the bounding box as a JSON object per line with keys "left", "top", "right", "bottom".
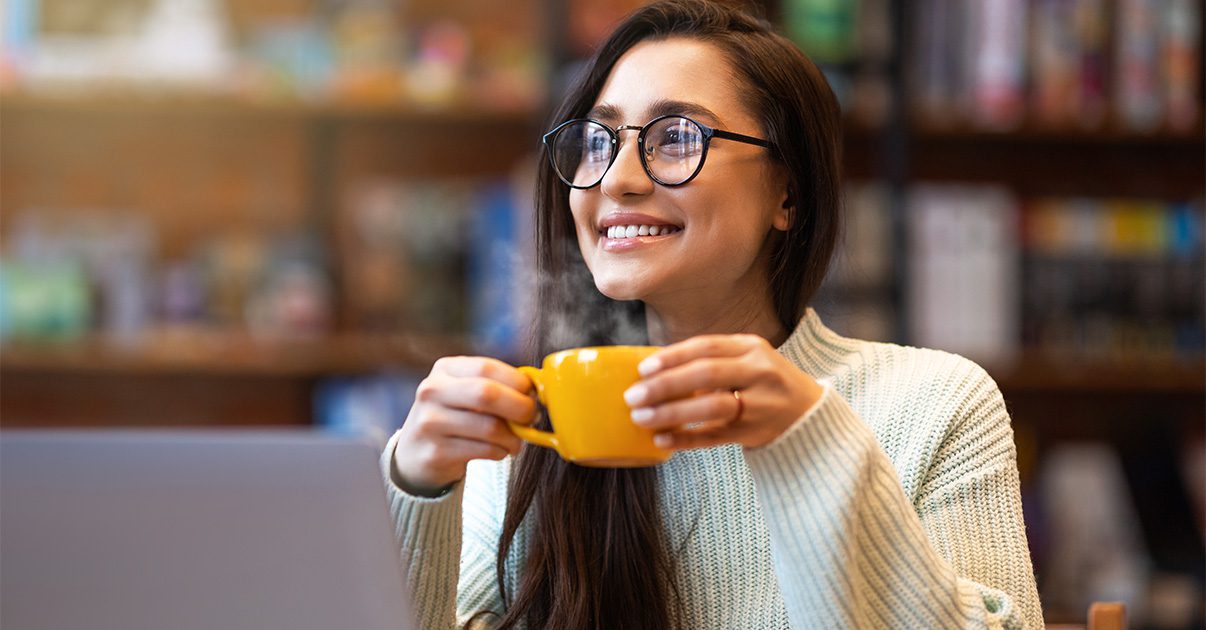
{"left": 0, "top": 329, "right": 468, "bottom": 427}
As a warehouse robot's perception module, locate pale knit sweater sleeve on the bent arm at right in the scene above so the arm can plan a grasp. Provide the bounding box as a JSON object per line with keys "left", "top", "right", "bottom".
{"left": 745, "top": 371, "right": 1042, "bottom": 628}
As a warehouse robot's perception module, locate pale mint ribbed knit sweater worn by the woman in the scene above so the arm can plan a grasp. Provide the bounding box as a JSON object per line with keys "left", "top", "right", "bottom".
{"left": 381, "top": 310, "right": 1042, "bottom": 629}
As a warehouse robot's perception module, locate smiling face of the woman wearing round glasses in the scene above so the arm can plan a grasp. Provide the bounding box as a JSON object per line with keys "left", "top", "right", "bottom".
{"left": 569, "top": 39, "right": 788, "bottom": 308}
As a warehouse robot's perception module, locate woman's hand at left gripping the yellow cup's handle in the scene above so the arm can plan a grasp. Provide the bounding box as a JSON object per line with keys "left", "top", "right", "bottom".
{"left": 393, "top": 356, "right": 535, "bottom": 496}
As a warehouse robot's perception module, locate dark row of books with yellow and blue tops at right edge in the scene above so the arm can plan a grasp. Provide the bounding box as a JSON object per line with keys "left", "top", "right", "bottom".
{"left": 1021, "top": 198, "right": 1206, "bottom": 362}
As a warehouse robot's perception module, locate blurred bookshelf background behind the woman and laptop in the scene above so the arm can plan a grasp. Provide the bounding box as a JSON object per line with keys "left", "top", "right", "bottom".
{"left": 0, "top": 0, "right": 1206, "bottom": 628}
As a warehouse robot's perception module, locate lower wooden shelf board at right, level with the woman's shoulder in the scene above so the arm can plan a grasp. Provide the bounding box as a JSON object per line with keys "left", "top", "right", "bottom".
{"left": 985, "top": 354, "right": 1206, "bottom": 395}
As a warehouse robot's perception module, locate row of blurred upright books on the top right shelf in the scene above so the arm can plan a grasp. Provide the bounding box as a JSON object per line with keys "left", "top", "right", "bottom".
{"left": 906, "top": 0, "right": 1202, "bottom": 133}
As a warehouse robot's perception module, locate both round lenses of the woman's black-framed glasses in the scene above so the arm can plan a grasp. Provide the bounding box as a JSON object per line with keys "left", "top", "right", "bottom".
{"left": 552, "top": 116, "right": 704, "bottom": 188}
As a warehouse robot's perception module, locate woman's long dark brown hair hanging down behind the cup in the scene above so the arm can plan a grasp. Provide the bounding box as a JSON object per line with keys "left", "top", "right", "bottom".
{"left": 497, "top": 0, "right": 841, "bottom": 630}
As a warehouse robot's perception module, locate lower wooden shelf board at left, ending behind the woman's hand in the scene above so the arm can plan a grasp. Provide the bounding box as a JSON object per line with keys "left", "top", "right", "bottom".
{"left": 0, "top": 331, "right": 468, "bottom": 378}
